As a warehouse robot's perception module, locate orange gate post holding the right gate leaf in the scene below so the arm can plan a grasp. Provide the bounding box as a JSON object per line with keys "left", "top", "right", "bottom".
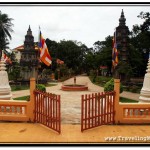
{"left": 114, "top": 79, "right": 120, "bottom": 124}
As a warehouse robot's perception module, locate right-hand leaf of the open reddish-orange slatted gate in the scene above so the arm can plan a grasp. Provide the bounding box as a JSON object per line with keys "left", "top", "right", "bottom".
{"left": 81, "top": 92, "right": 115, "bottom": 131}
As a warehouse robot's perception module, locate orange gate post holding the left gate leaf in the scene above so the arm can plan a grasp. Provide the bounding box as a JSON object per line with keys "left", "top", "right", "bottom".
{"left": 29, "top": 78, "right": 36, "bottom": 122}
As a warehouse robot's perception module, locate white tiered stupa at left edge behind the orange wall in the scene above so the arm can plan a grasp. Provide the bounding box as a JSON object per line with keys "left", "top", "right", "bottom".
{"left": 0, "top": 53, "right": 12, "bottom": 100}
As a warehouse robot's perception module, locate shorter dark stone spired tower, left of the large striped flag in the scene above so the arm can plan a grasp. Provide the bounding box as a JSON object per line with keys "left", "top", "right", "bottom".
{"left": 20, "top": 25, "right": 38, "bottom": 81}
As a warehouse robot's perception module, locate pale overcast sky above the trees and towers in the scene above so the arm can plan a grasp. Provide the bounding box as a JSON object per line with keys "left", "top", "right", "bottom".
{"left": 0, "top": 5, "right": 150, "bottom": 49}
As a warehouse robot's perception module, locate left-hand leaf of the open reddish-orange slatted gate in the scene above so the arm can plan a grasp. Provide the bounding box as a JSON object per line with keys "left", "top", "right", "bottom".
{"left": 34, "top": 90, "right": 61, "bottom": 133}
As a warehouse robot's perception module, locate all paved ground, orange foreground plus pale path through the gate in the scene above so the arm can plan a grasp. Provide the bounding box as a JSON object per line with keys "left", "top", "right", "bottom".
{"left": 0, "top": 76, "right": 146, "bottom": 144}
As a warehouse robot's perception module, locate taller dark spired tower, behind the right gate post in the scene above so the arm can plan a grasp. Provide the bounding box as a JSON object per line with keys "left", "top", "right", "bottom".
{"left": 116, "top": 9, "right": 129, "bottom": 81}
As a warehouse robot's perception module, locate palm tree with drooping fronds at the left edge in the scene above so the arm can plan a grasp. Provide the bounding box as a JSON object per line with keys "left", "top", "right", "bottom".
{"left": 0, "top": 11, "right": 13, "bottom": 60}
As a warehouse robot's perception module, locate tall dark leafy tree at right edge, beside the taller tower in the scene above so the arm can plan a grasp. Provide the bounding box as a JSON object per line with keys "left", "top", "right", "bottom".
{"left": 129, "top": 12, "right": 150, "bottom": 76}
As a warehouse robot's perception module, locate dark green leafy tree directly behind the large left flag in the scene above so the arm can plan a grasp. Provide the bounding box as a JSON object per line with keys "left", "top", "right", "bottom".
{"left": 46, "top": 39, "right": 89, "bottom": 74}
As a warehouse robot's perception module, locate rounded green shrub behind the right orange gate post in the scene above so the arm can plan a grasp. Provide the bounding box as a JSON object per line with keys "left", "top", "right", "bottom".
{"left": 104, "top": 78, "right": 123, "bottom": 93}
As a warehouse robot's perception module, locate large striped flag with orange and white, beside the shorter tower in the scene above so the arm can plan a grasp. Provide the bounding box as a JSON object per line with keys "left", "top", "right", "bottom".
{"left": 39, "top": 31, "right": 52, "bottom": 66}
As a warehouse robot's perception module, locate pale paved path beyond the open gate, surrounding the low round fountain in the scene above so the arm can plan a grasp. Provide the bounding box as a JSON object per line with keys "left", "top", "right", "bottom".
{"left": 12, "top": 76, "right": 139, "bottom": 124}
